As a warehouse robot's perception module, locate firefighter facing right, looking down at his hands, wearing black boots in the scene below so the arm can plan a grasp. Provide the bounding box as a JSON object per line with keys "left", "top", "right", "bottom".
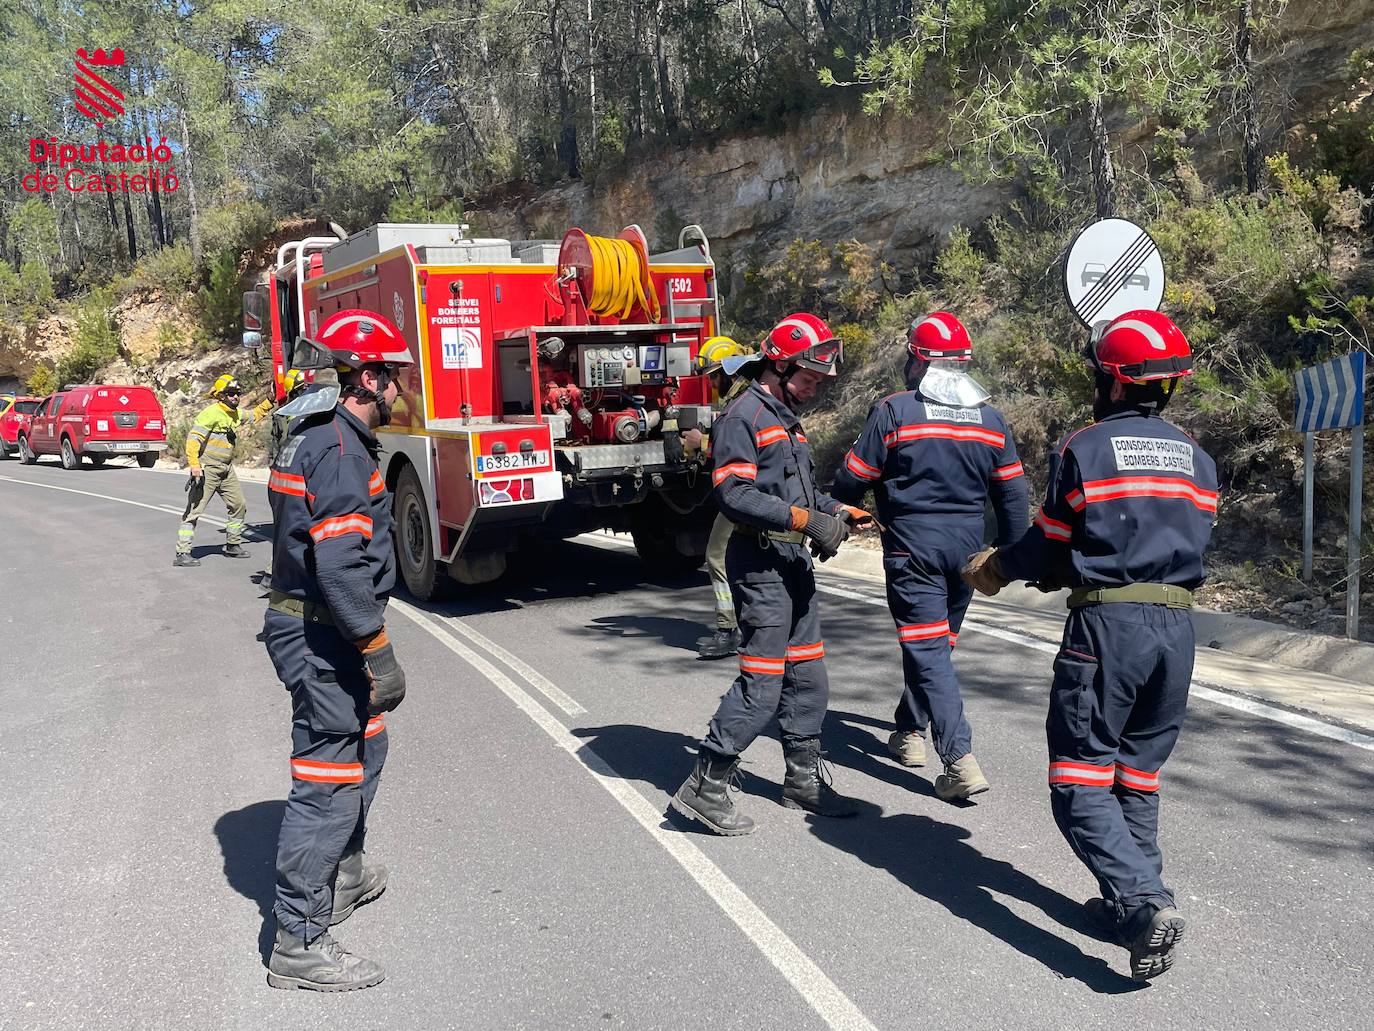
{"left": 671, "top": 313, "right": 871, "bottom": 834}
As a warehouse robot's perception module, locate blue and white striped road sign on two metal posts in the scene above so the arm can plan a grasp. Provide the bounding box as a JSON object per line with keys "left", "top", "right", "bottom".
{"left": 1293, "top": 351, "right": 1364, "bottom": 639}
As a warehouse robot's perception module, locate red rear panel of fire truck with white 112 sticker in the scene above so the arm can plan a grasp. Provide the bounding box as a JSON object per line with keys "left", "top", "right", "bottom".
{"left": 425, "top": 272, "right": 497, "bottom": 419}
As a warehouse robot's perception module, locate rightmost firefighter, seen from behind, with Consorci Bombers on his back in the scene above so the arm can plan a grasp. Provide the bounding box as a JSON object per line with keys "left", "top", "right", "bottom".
{"left": 966, "top": 311, "right": 1217, "bottom": 980}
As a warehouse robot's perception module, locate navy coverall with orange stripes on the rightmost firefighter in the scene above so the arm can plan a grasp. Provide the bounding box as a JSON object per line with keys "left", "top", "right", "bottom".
{"left": 998, "top": 408, "right": 1217, "bottom": 922}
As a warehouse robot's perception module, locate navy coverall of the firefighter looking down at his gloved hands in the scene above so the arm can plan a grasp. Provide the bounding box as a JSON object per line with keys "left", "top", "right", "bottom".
{"left": 702, "top": 384, "right": 845, "bottom": 756}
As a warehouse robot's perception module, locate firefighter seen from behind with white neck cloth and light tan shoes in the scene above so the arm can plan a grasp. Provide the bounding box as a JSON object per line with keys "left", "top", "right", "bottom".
{"left": 831, "top": 312, "right": 1026, "bottom": 801}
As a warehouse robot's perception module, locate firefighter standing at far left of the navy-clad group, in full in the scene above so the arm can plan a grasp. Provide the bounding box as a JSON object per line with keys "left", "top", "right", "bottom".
{"left": 264, "top": 309, "right": 412, "bottom": 991}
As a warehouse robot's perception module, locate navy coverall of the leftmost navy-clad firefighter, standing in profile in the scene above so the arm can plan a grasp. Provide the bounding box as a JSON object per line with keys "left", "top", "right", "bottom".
{"left": 264, "top": 406, "right": 396, "bottom": 942}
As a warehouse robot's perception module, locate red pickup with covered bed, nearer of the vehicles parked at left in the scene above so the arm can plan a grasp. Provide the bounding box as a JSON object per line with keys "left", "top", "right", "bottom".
{"left": 18, "top": 385, "right": 168, "bottom": 469}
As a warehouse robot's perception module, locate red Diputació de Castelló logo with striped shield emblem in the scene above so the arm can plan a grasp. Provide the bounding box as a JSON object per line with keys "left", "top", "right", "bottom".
{"left": 23, "top": 47, "right": 181, "bottom": 194}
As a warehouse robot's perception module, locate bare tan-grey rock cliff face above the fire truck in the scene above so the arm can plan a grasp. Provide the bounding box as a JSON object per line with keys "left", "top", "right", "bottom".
{"left": 473, "top": 103, "right": 1007, "bottom": 287}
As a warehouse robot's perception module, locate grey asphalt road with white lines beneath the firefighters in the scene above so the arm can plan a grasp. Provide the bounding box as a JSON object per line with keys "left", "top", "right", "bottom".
{"left": 0, "top": 462, "right": 1374, "bottom": 1031}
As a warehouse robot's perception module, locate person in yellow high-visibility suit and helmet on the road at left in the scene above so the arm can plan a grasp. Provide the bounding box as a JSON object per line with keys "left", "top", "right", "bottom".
{"left": 172, "top": 374, "right": 272, "bottom": 566}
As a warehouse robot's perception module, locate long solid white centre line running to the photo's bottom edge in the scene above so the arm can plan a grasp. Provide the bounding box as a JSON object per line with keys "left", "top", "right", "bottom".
{"left": 390, "top": 598, "right": 877, "bottom": 1031}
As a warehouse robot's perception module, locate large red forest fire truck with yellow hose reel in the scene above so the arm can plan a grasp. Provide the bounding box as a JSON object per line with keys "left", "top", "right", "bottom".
{"left": 245, "top": 224, "right": 719, "bottom": 599}
